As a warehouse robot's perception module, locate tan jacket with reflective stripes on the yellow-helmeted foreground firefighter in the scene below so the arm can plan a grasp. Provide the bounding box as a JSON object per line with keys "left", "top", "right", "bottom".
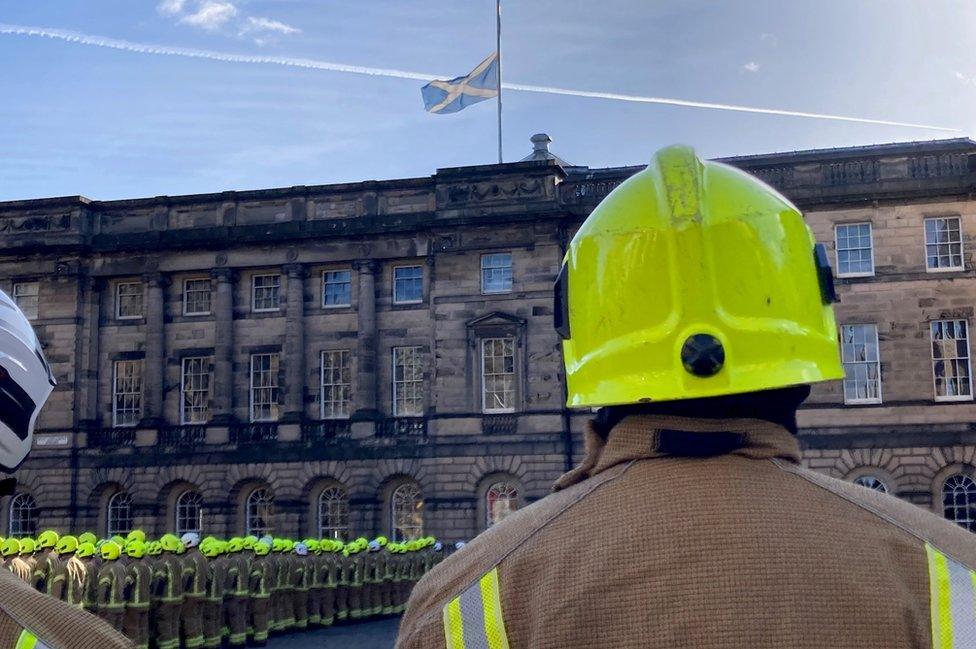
{"left": 397, "top": 416, "right": 976, "bottom": 649}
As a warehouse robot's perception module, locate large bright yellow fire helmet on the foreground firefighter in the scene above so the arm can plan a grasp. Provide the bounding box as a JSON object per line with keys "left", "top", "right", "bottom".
{"left": 555, "top": 146, "right": 844, "bottom": 407}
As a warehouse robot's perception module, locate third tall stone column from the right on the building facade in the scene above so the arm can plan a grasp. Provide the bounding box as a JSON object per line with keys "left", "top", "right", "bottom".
{"left": 210, "top": 268, "right": 235, "bottom": 424}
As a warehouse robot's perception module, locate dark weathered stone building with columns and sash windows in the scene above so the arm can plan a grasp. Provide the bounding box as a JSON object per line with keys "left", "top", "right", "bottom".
{"left": 0, "top": 138, "right": 976, "bottom": 540}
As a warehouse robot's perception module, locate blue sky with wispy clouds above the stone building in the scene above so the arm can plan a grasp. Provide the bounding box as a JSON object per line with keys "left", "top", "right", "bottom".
{"left": 0, "top": 0, "right": 976, "bottom": 200}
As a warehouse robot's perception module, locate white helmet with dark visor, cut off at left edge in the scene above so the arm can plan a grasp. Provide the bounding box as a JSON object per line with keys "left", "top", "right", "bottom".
{"left": 0, "top": 291, "right": 55, "bottom": 471}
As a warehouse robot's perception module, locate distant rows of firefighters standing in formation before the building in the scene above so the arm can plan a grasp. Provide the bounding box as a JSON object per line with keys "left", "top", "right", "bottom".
{"left": 0, "top": 530, "right": 450, "bottom": 649}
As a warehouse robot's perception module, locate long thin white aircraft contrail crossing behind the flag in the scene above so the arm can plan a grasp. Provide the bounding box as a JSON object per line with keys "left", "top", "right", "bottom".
{"left": 0, "top": 23, "right": 961, "bottom": 133}
